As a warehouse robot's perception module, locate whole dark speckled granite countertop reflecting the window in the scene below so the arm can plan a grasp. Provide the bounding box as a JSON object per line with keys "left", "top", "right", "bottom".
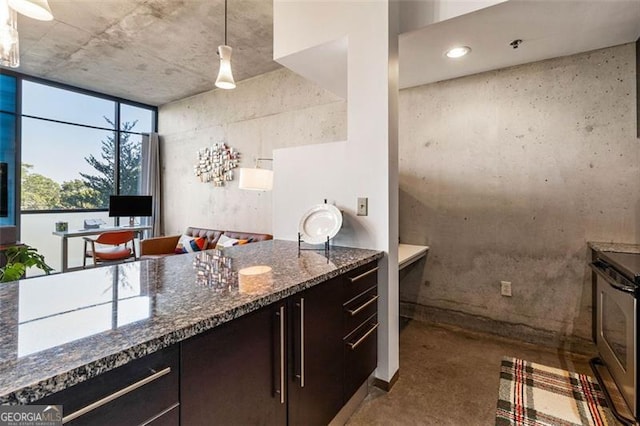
{"left": 0, "top": 240, "right": 383, "bottom": 404}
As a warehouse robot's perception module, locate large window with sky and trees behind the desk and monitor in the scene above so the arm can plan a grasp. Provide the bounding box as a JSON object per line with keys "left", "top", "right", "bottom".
{"left": 20, "top": 78, "right": 156, "bottom": 213}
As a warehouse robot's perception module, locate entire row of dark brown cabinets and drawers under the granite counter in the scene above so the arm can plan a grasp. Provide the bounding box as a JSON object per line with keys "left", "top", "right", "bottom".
{"left": 38, "top": 262, "right": 378, "bottom": 426}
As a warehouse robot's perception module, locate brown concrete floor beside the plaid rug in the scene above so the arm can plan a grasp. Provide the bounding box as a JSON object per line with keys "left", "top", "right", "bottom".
{"left": 347, "top": 320, "right": 593, "bottom": 426}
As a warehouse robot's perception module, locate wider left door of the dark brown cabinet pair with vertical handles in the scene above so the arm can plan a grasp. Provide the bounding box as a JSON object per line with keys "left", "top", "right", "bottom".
{"left": 180, "top": 303, "right": 287, "bottom": 426}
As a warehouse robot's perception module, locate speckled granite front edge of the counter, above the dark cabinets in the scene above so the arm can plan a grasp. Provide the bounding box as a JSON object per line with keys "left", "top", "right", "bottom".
{"left": 0, "top": 252, "right": 384, "bottom": 405}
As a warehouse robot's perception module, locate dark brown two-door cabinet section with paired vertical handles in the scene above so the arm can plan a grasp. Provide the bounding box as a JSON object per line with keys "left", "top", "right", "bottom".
{"left": 180, "top": 277, "right": 344, "bottom": 426}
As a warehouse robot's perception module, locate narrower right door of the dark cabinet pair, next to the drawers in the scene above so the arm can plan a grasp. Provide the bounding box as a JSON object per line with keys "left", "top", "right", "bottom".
{"left": 288, "top": 277, "right": 344, "bottom": 426}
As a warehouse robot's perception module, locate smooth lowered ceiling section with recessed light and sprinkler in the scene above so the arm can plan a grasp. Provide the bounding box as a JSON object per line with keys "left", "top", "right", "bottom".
{"left": 400, "top": 0, "right": 640, "bottom": 88}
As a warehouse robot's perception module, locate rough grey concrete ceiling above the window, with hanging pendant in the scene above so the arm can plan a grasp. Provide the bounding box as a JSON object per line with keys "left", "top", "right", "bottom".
{"left": 6, "top": 0, "right": 279, "bottom": 105}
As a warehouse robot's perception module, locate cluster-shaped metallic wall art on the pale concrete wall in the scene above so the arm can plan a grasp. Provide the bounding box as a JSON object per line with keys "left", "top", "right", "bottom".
{"left": 193, "top": 143, "right": 240, "bottom": 186}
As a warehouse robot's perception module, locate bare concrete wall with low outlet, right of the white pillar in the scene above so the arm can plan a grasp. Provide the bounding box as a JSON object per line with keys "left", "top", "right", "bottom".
{"left": 400, "top": 44, "right": 640, "bottom": 348}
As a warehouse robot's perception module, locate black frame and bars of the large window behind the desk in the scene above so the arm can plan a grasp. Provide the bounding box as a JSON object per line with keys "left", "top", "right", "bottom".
{"left": 0, "top": 68, "right": 158, "bottom": 220}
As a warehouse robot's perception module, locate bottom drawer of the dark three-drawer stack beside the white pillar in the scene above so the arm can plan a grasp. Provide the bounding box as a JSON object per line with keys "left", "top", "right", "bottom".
{"left": 344, "top": 315, "right": 378, "bottom": 403}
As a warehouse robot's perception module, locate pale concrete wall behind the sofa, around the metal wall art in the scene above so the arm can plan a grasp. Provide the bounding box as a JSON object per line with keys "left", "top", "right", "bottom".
{"left": 159, "top": 69, "right": 347, "bottom": 234}
